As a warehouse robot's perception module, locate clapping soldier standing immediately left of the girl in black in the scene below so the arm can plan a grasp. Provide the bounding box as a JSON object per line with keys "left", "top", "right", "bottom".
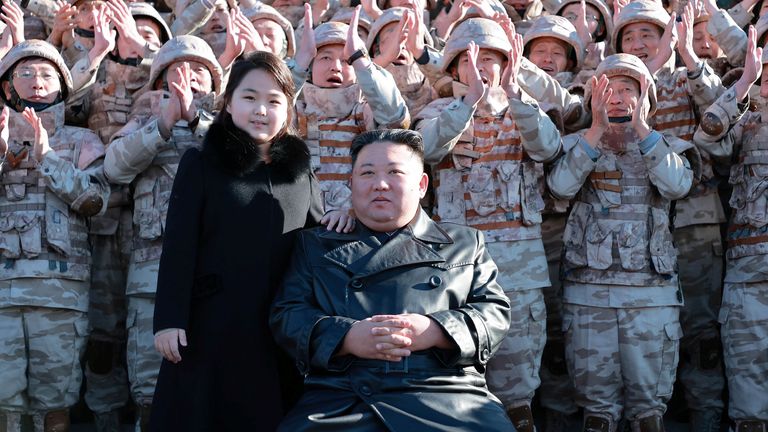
{"left": 104, "top": 36, "right": 222, "bottom": 431}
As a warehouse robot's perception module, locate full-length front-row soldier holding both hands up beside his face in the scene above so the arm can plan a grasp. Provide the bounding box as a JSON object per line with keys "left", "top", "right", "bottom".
{"left": 547, "top": 54, "right": 695, "bottom": 432}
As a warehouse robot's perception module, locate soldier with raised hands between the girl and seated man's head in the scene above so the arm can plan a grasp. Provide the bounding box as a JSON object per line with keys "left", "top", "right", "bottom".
{"left": 289, "top": 7, "right": 410, "bottom": 219}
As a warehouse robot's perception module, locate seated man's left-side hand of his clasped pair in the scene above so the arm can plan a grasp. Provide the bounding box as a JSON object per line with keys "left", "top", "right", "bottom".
{"left": 337, "top": 316, "right": 412, "bottom": 361}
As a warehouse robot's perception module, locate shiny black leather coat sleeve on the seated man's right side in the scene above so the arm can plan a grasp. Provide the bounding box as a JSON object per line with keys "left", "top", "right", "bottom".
{"left": 427, "top": 231, "right": 511, "bottom": 367}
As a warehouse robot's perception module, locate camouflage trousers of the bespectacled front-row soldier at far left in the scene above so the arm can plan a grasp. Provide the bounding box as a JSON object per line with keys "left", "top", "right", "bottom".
{"left": 0, "top": 306, "right": 88, "bottom": 412}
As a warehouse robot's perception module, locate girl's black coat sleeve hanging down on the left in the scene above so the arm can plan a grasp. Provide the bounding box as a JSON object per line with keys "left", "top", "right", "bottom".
{"left": 153, "top": 149, "right": 204, "bottom": 333}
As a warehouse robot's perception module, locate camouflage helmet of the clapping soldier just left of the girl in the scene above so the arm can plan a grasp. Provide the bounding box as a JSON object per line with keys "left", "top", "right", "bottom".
{"left": 145, "top": 35, "right": 223, "bottom": 94}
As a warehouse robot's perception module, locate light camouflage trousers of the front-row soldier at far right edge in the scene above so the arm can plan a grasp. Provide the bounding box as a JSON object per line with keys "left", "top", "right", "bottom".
{"left": 719, "top": 282, "right": 768, "bottom": 422}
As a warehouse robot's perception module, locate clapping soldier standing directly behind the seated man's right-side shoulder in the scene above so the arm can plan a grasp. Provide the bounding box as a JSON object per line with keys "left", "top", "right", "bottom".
{"left": 416, "top": 18, "right": 560, "bottom": 432}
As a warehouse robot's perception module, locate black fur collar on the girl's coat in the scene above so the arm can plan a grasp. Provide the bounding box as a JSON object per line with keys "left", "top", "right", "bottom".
{"left": 203, "top": 118, "right": 311, "bottom": 182}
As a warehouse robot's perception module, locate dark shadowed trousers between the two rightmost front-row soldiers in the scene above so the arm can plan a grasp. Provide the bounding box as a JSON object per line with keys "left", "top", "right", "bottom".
{"left": 673, "top": 224, "right": 725, "bottom": 413}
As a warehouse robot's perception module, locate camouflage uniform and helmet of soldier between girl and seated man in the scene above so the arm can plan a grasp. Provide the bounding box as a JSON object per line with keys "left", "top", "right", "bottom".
{"left": 294, "top": 22, "right": 410, "bottom": 212}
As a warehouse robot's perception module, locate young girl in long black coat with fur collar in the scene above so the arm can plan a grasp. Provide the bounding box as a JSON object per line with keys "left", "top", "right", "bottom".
{"left": 150, "top": 52, "right": 322, "bottom": 431}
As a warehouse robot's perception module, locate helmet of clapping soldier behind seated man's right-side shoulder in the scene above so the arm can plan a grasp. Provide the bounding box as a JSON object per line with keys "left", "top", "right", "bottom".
{"left": 442, "top": 18, "right": 512, "bottom": 72}
